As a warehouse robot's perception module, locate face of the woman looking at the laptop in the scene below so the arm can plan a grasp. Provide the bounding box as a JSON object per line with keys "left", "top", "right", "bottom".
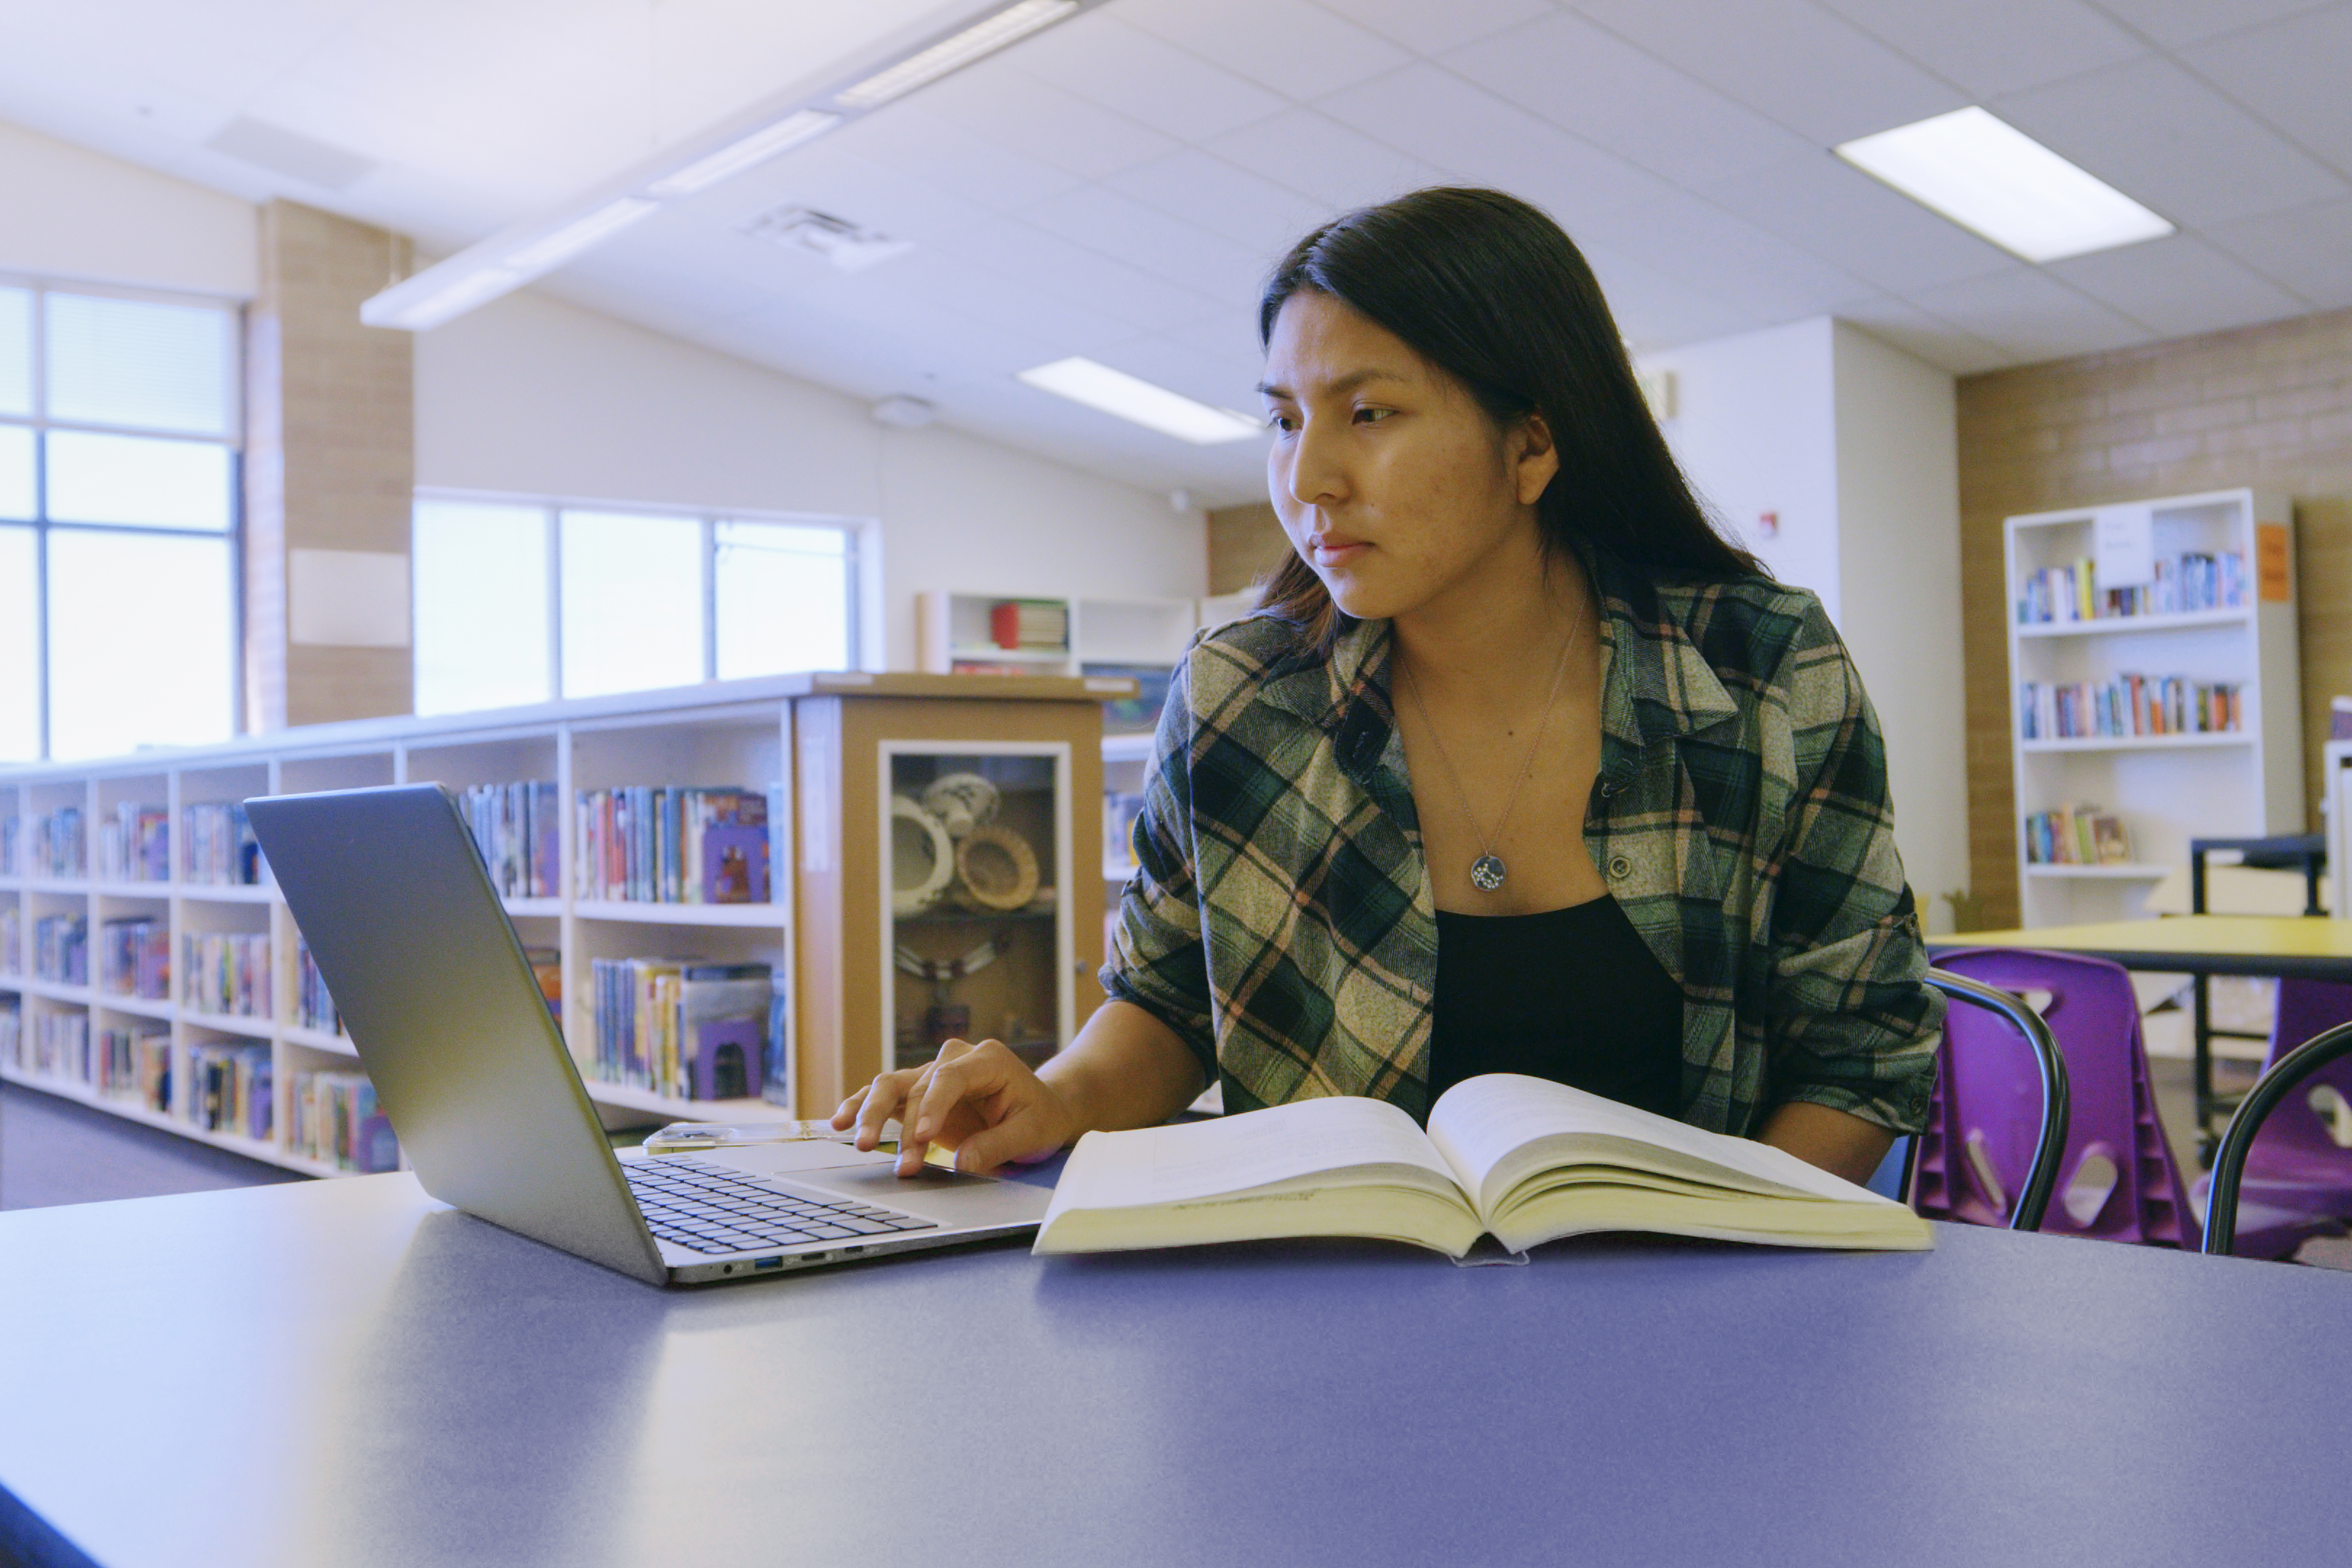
{"left": 1261, "top": 291, "right": 1559, "bottom": 621}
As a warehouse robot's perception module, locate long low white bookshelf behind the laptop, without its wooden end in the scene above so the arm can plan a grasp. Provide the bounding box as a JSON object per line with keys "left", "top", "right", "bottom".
{"left": 0, "top": 675, "right": 828, "bottom": 1175}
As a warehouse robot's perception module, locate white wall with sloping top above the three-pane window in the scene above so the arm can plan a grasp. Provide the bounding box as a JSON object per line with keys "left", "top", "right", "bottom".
{"left": 416, "top": 291, "right": 1209, "bottom": 670}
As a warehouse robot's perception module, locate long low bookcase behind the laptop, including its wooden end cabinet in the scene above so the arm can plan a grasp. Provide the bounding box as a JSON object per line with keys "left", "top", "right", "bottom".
{"left": 0, "top": 673, "right": 1133, "bottom": 1175}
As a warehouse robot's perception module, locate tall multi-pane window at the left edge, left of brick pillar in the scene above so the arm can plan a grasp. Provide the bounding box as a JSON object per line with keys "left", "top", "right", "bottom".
{"left": 0, "top": 284, "right": 237, "bottom": 762}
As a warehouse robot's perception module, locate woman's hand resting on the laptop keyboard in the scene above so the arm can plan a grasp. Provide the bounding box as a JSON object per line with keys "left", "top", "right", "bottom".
{"left": 832, "top": 1039, "right": 1087, "bottom": 1175}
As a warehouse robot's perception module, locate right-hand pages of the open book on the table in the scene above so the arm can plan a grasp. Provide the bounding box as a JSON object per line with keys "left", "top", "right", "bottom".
{"left": 1430, "top": 1072, "right": 1886, "bottom": 1229}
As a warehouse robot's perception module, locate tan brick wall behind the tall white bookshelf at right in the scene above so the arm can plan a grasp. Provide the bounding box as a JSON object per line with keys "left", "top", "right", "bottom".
{"left": 1959, "top": 310, "right": 2352, "bottom": 924}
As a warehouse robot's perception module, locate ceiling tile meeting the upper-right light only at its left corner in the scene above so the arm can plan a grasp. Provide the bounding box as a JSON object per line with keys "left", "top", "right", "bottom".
{"left": 1442, "top": 14, "right": 1811, "bottom": 186}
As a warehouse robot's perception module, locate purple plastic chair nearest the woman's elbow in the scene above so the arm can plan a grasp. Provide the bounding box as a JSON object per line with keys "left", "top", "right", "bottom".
{"left": 1912, "top": 947, "right": 2201, "bottom": 1251}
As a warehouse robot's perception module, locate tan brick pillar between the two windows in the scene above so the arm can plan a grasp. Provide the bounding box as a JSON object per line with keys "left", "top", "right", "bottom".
{"left": 244, "top": 202, "right": 416, "bottom": 731}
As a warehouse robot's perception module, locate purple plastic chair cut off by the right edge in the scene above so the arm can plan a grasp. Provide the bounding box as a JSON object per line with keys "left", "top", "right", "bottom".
{"left": 2192, "top": 978, "right": 2352, "bottom": 1258}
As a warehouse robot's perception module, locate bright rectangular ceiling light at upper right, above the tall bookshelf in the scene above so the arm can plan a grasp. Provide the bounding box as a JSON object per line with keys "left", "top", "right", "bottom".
{"left": 1837, "top": 108, "right": 2173, "bottom": 261}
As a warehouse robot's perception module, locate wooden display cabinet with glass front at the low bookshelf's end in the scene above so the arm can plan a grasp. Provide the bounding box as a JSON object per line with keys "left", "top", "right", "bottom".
{"left": 793, "top": 675, "right": 1133, "bottom": 1114}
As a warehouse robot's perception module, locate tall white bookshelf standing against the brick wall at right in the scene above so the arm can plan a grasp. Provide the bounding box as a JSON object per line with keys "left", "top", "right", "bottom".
{"left": 2004, "top": 489, "right": 2302, "bottom": 926}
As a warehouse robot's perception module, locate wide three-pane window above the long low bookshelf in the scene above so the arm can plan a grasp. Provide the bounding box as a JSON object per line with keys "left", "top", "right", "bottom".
{"left": 411, "top": 493, "right": 858, "bottom": 724}
